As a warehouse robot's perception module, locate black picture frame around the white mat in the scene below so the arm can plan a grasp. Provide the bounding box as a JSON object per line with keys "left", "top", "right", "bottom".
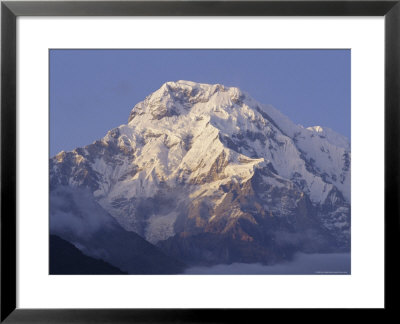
{"left": 0, "top": 0, "right": 400, "bottom": 323}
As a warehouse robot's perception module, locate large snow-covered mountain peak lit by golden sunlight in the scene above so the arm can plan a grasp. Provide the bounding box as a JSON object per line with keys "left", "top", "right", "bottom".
{"left": 50, "top": 81, "right": 351, "bottom": 265}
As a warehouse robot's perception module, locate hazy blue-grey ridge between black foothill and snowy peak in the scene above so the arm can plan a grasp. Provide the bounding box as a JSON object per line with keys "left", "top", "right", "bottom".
{"left": 50, "top": 186, "right": 185, "bottom": 274}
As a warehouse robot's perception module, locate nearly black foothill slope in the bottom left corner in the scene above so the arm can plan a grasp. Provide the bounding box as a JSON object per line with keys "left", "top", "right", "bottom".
{"left": 49, "top": 235, "right": 125, "bottom": 275}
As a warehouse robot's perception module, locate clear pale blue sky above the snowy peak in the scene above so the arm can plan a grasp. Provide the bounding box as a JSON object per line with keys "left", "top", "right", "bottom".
{"left": 50, "top": 50, "right": 350, "bottom": 156}
